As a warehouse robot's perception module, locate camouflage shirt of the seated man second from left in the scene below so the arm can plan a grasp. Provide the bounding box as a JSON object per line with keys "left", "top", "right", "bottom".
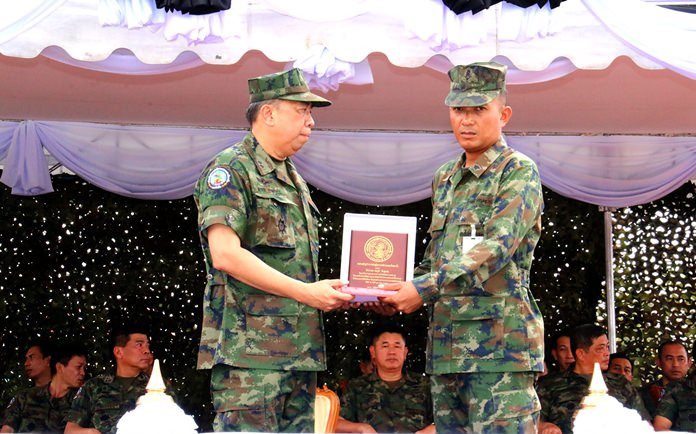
{"left": 0, "top": 383, "right": 77, "bottom": 433}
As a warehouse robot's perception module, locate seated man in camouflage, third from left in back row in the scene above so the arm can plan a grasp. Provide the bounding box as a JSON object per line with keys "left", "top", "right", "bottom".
{"left": 65, "top": 328, "right": 155, "bottom": 434}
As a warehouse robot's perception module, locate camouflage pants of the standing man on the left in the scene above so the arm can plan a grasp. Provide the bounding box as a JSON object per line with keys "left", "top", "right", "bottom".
{"left": 210, "top": 365, "right": 317, "bottom": 433}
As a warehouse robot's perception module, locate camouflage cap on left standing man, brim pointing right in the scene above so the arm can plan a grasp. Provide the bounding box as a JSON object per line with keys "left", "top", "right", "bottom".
{"left": 249, "top": 68, "right": 331, "bottom": 107}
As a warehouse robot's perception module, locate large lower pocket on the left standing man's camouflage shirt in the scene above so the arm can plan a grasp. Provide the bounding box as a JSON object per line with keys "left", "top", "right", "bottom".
{"left": 240, "top": 294, "right": 300, "bottom": 357}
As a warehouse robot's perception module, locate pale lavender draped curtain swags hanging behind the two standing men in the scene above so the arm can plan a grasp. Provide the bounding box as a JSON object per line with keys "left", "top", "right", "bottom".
{"left": 0, "top": 121, "right": 696, "bottom": 207}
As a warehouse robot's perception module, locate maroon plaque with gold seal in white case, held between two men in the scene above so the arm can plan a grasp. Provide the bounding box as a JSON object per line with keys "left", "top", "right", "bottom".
{"left": 341, "top": 213, "right": 417, "bottom": 302}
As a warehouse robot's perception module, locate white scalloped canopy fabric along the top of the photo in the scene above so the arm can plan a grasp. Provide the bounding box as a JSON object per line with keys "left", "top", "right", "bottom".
{"left": 0, "top": 0, "right": 668, "bottom": 71}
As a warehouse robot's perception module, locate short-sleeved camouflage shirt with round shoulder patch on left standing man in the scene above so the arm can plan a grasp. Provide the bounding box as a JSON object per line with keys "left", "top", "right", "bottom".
{"left": 194, "top": 134, "right": 326, "bottom": 371}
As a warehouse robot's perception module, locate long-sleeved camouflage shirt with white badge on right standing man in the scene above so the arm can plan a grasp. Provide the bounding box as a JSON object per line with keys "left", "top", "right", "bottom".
{"left": 413, "top": 136, "right": 544, "bottom": 374}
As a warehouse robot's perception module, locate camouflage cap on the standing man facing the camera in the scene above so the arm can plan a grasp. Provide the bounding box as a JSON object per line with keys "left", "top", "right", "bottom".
{"left": 445, "top": 62, "right": 507, "bottom": 107}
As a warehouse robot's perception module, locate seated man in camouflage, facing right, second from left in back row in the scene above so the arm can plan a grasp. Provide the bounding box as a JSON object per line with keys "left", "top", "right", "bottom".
{"left": 0, "top": 345, "right": 87, "bottom": 433}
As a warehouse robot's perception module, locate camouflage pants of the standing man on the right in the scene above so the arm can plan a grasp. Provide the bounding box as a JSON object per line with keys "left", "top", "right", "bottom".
{"left": 430, "top": 372, "right": 541, "bottom": 434}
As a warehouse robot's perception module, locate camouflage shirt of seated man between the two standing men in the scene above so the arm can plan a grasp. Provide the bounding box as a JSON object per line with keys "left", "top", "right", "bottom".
{"left": 341, "top": 372, "right": 433, "bottom": 433}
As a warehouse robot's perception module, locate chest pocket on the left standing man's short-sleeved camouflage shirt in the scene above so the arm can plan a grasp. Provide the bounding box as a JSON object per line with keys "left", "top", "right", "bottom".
{"left": 254, "top": 191, "right": 297, "bottom": 249}
